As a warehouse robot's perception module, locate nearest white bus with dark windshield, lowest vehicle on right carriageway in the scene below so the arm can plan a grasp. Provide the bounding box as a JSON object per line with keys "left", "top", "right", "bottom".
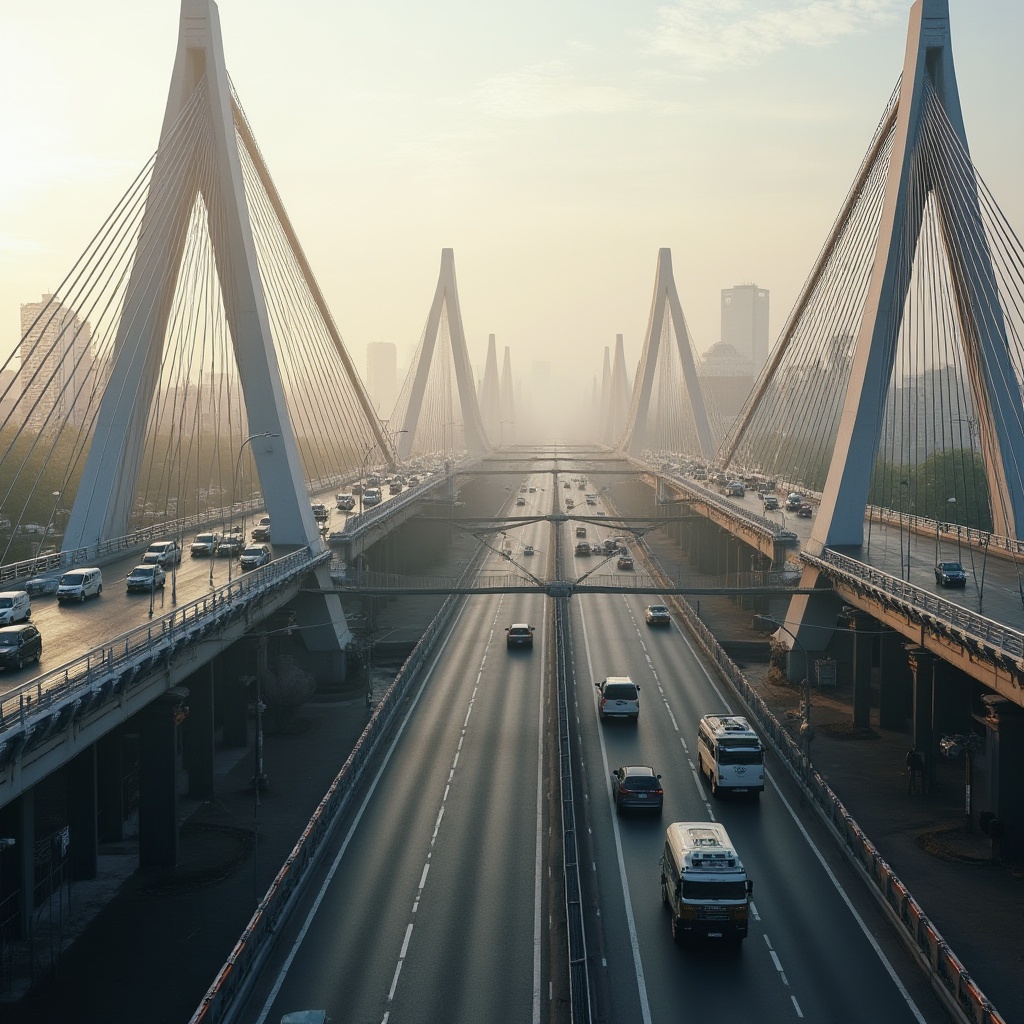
{"left": 662, "top": 821, "right": 754, "bottom": 948}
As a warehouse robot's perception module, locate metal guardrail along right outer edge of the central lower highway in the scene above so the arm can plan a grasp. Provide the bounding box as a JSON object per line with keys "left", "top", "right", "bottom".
{"left": 638, "top": 559, "right": 1006, "bottom": 1024}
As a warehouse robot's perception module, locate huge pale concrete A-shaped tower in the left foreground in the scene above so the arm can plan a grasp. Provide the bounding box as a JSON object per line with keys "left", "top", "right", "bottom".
{"left": 63, "top": 0, "right": 370, "bottom": 649}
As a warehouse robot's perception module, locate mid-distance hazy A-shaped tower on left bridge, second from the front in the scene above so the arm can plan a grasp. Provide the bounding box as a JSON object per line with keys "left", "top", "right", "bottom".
{"left": 392, "top": 249, "right": 489, "bottom": 459}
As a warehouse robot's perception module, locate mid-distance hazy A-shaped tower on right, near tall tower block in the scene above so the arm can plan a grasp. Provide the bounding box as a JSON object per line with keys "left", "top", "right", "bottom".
{"left": 612, "top": 249, "right": 715, "bottom": 459}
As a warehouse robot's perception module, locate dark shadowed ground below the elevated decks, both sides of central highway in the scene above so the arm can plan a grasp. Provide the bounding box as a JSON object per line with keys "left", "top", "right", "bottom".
{"left": 0, "top": 565, "right": 1024, "bottom": 1024}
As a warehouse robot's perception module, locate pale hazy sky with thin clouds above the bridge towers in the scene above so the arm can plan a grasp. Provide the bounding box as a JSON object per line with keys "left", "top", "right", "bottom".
{"left": 0, "top": 0, "right": 1024, "bottom": 380}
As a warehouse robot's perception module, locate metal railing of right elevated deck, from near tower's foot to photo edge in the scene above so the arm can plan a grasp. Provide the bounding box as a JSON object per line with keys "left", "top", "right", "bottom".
{"left": 801, "top": 548, "right": 1024, "bottom": 658}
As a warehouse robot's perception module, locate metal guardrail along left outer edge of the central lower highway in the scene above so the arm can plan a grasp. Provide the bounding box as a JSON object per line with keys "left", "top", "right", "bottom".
{"left": 189, "top": 499, "right": 495, "bottom": 1024}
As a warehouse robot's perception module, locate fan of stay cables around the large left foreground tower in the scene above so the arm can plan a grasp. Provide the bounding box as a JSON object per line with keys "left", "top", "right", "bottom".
{"left": 0, "top": 80, "right": 387, "bottom": 561}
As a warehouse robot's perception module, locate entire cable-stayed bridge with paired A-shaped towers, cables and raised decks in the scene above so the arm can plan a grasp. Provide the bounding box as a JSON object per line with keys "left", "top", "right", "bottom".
{"left": 0, "top": 0, "right": 1024, "bottom": 1011}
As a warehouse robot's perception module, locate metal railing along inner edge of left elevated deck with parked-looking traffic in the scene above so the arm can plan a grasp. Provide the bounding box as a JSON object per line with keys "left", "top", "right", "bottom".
{"left": 0, "top": 548, "right": 330, "bottom": 741}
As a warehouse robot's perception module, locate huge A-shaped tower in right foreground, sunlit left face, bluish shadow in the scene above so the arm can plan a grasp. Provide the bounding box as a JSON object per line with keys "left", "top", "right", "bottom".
{"left": 787, "top": 0, "right": 1024, "bottom": 646}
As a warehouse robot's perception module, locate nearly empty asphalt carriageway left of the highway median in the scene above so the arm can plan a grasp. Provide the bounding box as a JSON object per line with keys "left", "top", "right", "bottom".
{"left": 237, "top": 475, "right": 551, "bottom": 1024}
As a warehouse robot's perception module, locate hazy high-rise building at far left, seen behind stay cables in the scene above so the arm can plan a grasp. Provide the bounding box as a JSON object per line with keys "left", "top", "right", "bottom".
{"left": 18, "top": 295, "right": 92, "bottom": 430}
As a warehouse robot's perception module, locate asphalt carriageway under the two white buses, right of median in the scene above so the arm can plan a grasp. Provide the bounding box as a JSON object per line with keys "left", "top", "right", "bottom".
{"left": 566, "top": 493, "right": 942, "bottom": 1024}
